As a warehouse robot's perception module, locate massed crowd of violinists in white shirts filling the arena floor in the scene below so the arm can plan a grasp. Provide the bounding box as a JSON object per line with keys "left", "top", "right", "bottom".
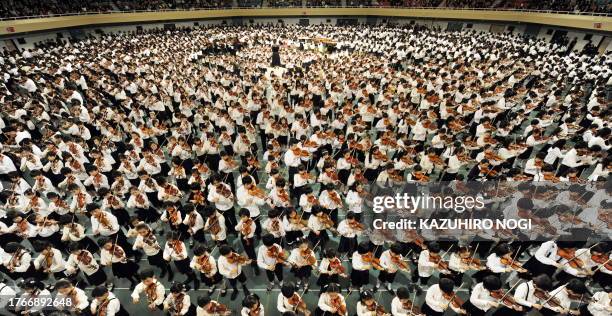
{"left": 0, "top": 26, "right": 612, "bottom": 316}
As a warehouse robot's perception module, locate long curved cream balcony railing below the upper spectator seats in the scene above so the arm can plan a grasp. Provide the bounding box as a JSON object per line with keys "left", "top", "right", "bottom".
{"left": 0, "top": 6, "right": 612, "bottom": 21}
